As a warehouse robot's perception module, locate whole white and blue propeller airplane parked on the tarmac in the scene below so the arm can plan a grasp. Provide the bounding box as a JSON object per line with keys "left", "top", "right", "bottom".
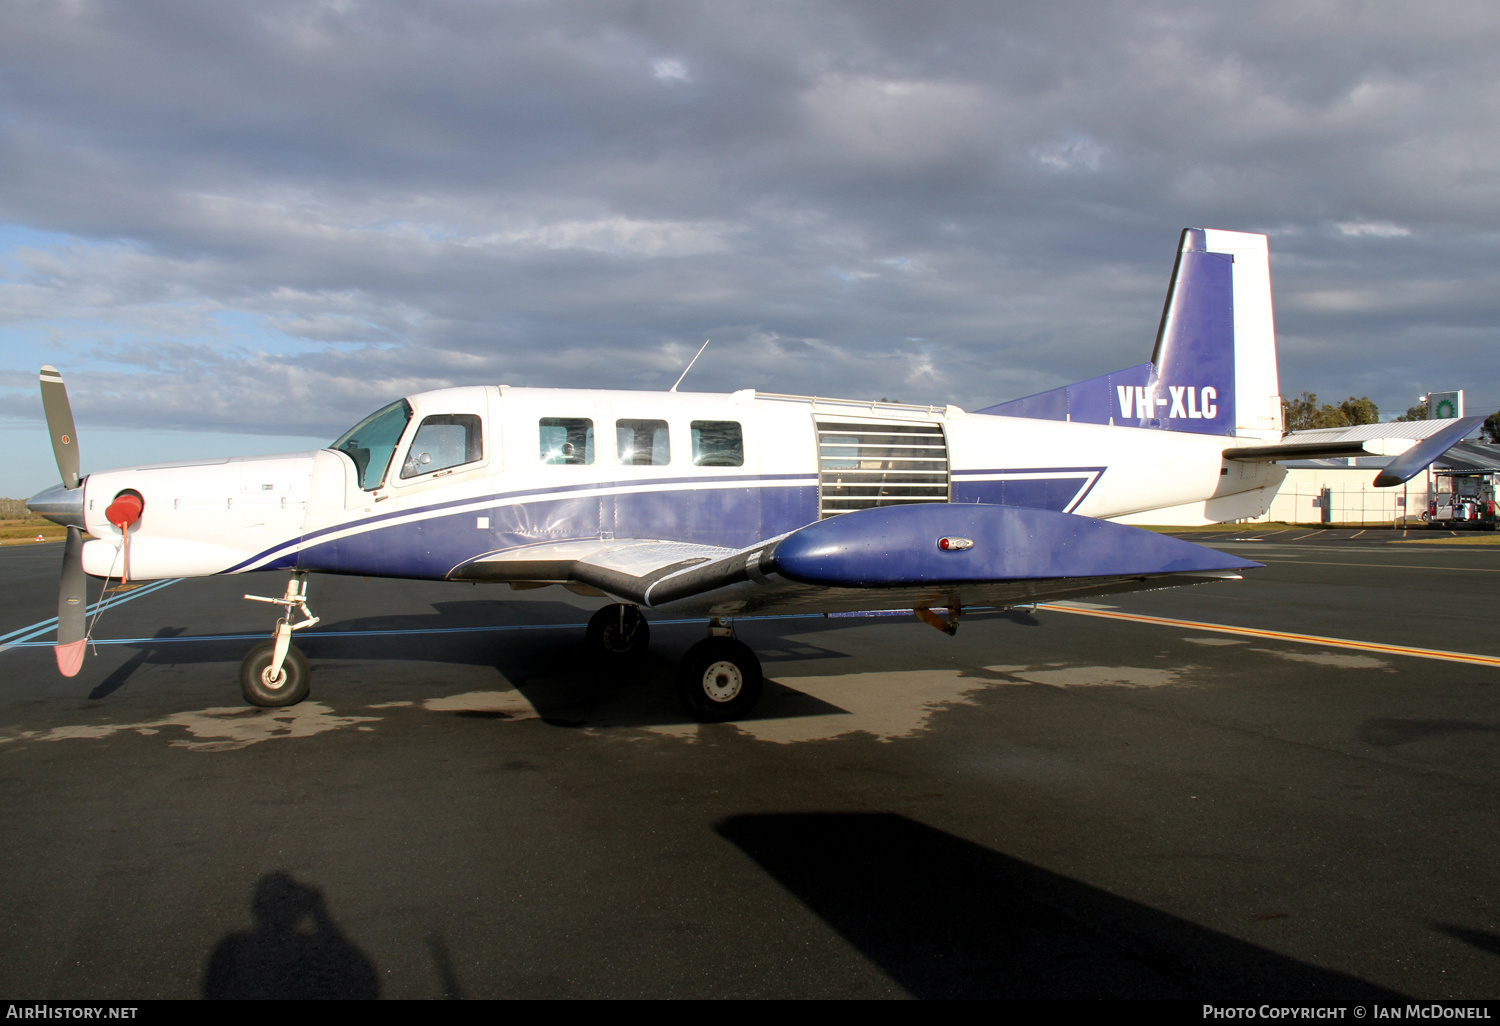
{"left": 29, "top": 228, "right": 1479, "bottom": 720}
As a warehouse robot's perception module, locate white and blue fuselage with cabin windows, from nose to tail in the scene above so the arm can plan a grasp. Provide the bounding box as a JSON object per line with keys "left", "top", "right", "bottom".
{"left": 73, "top": 386, "right": 1283, "bottom": 579}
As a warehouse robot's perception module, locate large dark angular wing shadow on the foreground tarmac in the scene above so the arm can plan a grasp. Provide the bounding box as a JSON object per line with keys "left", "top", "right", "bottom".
{"left": 717, "top": 813, "right": 1401, "bottom": 1002}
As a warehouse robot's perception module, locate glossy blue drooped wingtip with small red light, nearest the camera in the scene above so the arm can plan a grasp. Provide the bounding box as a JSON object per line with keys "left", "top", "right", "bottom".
{"left": 761, "top": 503, "right": 1260, "bottom": 588}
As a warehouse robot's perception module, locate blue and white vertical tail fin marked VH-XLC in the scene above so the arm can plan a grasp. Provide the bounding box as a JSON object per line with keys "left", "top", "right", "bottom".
{"left": 978, "top": 228, "right": 1281, "bottom": 440}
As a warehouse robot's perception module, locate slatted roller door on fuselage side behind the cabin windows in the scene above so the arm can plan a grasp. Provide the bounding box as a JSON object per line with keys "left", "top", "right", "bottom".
{"left": 818, "top": 420, "right": 948, "bottom": 519}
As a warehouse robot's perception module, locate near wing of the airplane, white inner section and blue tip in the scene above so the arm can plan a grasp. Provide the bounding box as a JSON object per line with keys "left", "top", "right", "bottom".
{"left": 452, "top": 503, "right": 1260, "bottom": 617}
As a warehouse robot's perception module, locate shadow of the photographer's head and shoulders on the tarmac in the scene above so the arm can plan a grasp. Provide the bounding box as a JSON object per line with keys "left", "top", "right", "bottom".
{"left": 203, "top": 872, "right": 380, "bottom": 1001}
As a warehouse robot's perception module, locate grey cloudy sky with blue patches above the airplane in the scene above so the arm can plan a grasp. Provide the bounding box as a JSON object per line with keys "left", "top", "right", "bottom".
{"left": 0, "top": 0, "right": 1500, "bottom": 495}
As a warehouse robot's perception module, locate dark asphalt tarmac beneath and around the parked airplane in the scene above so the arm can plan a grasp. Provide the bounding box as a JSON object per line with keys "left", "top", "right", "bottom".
{"left": 0, "top": 531, "right": 1500, "bottom": 1002}
